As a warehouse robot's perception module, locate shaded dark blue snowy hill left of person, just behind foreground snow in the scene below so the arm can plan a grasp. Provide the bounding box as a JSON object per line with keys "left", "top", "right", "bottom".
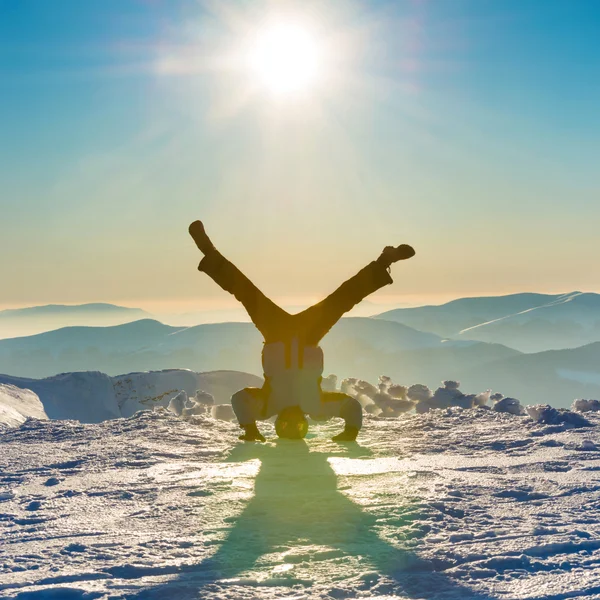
{"left": 0, "top": 369, "right": 262, "bottom": 424}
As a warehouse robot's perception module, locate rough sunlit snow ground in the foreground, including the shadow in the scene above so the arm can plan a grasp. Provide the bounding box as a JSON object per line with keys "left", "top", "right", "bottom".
{"left": 0, "top": 408, "right": 600, "bottom": 600}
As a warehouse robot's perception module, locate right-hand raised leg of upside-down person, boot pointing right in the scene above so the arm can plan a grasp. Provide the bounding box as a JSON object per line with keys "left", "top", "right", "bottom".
{"left": 295, "top": 244, "right": 415, "bottom": 345}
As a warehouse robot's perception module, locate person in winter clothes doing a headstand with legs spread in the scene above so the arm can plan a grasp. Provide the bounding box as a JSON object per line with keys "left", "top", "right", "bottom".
{"left": 189, "top": 221, "right": 415, "bottom": 442}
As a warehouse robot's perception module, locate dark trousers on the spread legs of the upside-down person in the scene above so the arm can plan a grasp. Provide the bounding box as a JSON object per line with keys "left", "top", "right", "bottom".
{"left": 198, "top": 250, "right": 392, "bottom": 346}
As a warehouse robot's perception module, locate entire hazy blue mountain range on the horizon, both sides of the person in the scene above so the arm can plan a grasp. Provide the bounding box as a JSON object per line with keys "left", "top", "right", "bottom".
{"left": 0, "top": 292, "right": 600, "bottom": 406}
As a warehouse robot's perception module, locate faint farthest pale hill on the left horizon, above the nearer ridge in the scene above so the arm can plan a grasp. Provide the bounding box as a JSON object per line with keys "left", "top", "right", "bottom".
{"left": 0, "top": 303, "right": 149, "bottom": 339}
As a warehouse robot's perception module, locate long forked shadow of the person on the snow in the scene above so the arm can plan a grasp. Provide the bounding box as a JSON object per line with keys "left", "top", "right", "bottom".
{"left": 131, "top": 440, "right": 490, "bottom": 600}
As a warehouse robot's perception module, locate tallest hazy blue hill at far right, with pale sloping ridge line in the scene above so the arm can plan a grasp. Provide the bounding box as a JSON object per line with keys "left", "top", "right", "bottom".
{"left": 377, "top": 292, "right": 600, "bottom": 352}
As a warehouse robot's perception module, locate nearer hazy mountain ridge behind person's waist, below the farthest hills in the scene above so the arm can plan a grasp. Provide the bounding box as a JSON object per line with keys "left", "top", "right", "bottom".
{"left": 0, "top": 317, "right": 600, "bottom": 406}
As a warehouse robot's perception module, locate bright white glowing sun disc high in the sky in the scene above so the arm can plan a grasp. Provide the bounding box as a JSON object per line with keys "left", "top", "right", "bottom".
{"left": 249, "top": 23, "right": 319, "bottom": 95}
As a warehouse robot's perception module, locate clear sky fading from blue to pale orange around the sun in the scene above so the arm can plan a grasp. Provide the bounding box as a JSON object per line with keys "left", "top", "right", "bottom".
{"left": 0, "top": 0, "right": 600, "bottom": 312}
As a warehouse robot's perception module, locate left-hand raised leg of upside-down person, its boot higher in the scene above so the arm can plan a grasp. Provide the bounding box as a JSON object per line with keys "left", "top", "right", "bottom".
{"left": 190, "top": 221, "right": 291, "bottom": 342}
